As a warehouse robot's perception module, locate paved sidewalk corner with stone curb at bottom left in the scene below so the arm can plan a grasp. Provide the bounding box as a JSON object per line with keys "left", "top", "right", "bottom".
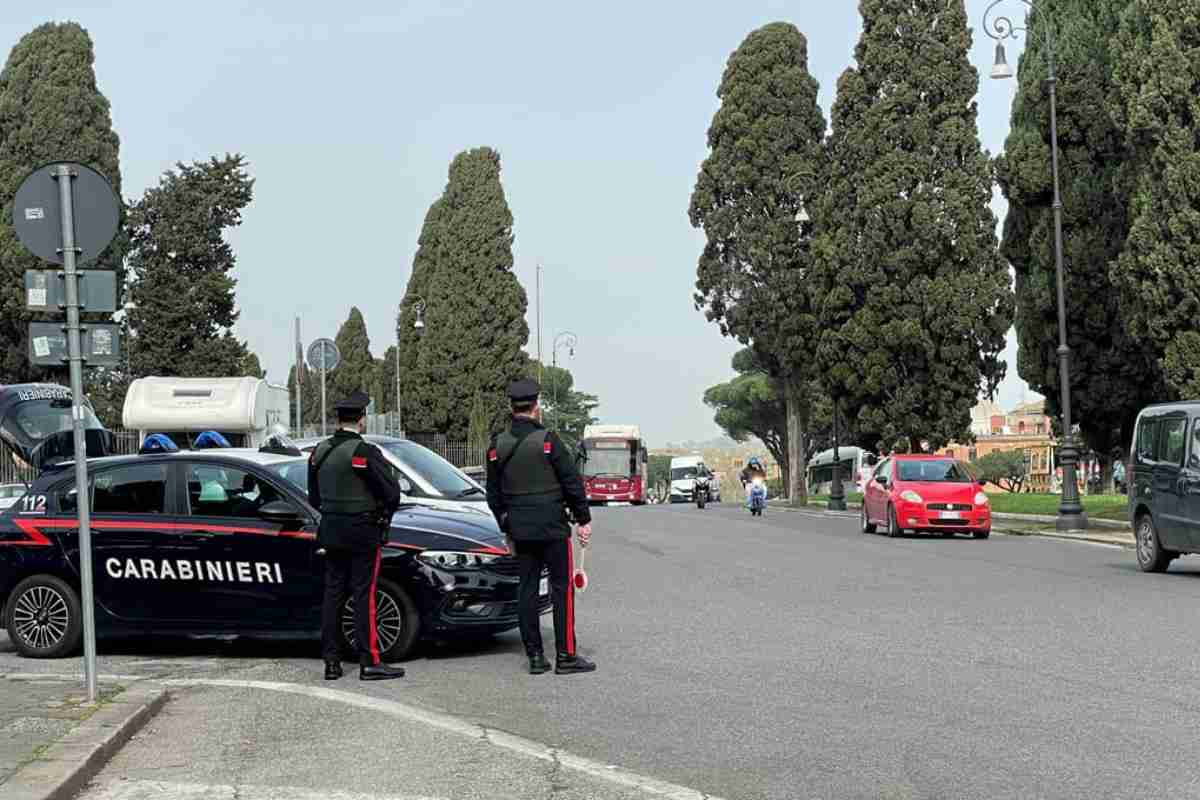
{"left": 0, "top": 676, "right": 166, "bottom": 800}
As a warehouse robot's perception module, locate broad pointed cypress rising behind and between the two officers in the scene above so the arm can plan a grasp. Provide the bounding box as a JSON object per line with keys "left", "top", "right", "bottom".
{"left": 400, "top": 148, "right": 529, "bottom": 439}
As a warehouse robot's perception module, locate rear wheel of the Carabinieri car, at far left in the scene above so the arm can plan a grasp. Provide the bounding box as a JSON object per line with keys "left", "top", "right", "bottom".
{"left": 5, "top": 575, "right": 83, "bottom": 658}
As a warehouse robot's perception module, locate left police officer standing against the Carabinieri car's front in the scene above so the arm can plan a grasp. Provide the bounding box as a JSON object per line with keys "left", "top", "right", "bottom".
{"left": 308, "top": 392, "right": 404, "bottom": 680}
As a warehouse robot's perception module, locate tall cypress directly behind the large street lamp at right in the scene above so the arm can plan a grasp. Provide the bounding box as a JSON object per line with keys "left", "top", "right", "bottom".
{"left": 996, "top": 0, "right": 1158, "bottom": 470}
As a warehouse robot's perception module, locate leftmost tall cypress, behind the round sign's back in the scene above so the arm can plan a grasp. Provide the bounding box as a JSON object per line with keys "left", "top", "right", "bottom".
{"left": 0, "top": 23, "right": 126, "bottom": 381}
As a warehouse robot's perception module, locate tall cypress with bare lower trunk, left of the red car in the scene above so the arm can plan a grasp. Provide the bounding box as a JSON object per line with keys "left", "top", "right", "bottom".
{"left": 689, "top": 23, "right": 826, "bottom": 504}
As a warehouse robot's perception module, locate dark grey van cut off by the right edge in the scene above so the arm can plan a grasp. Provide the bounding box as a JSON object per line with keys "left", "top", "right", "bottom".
{"left": 1129, "top": 402, "right": 1200, "bottom": 572}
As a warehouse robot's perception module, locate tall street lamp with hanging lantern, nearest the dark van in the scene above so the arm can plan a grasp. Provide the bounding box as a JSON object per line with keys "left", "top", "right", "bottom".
{"left": 983, "top": 0, "right": 1087, "bottom": 530}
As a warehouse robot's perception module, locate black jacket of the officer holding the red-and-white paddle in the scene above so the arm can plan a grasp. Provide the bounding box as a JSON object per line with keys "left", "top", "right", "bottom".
{"left": 487, "top": 416, "right": 592, "bottom": 541}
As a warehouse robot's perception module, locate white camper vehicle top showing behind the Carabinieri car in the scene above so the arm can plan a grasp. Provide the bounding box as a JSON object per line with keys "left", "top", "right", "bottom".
{"left": 121, "top": 378, "right": 292, "bottom": 449}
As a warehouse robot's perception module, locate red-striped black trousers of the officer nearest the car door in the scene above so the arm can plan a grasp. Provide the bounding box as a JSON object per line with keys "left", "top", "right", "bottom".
{"left": 320, "top": 547, "right": 382, "bottom": 666}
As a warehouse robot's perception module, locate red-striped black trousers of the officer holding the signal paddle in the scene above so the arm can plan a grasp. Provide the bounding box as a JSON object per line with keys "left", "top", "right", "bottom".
{"left": 516, "top": 539, "right": 575, "bottom": 656}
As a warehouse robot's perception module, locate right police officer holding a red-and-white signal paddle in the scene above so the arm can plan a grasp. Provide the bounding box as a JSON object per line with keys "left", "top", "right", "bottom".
{"left": 487, "top": 379, "right": 596, "bottom": 675}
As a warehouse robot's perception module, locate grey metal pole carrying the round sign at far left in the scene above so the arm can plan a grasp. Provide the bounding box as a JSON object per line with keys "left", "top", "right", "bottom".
{"left": 54, "top": 164, "right": 96, "bottom": 703}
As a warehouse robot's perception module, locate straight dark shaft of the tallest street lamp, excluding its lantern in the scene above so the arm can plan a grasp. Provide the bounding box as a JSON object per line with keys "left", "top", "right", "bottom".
{"left": 1046, "top": 15, "right": 1087, "bottom": 530}
